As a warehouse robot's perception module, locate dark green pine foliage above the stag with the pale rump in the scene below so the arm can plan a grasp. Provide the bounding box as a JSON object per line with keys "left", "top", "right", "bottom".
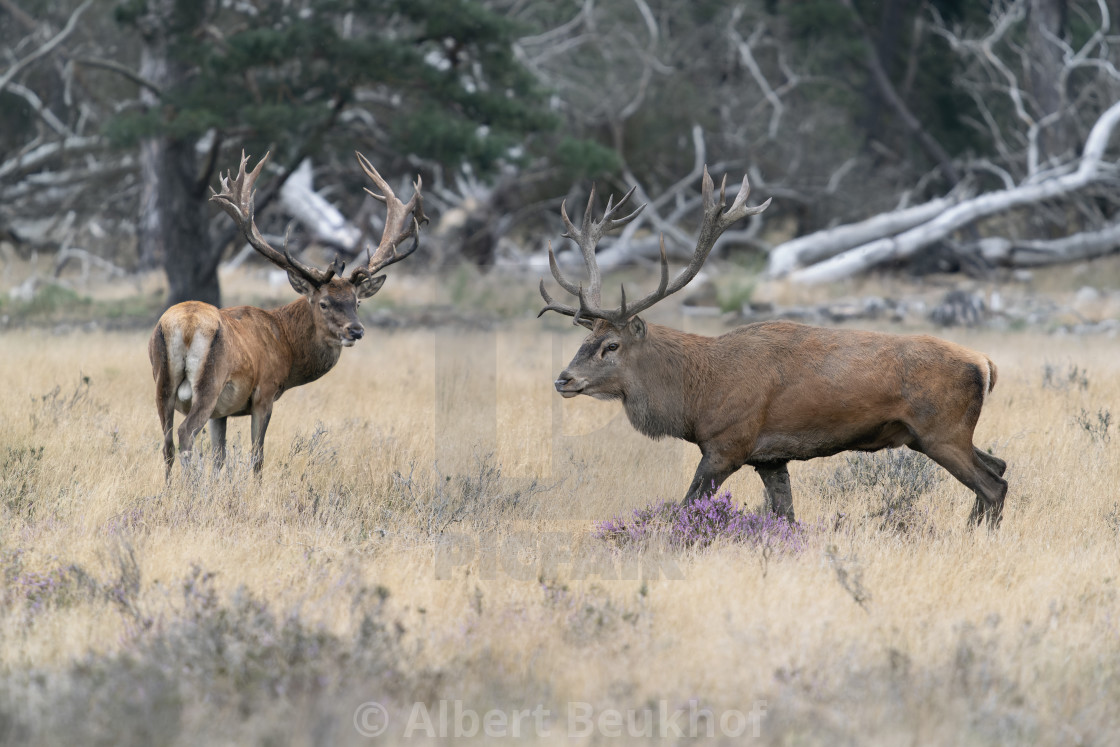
{"left": 105, "top": 0, "right": 557, "bottom": 172}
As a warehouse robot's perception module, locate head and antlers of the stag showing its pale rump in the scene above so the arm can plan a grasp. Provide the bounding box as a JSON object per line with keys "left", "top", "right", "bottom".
{"left": 211, "top": 152, "right": 428, "bottom": 347}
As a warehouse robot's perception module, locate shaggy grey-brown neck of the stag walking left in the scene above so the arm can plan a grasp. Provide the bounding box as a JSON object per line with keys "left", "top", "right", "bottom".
{"left": 622, "top": 325, "right": 711, "bottom": 441}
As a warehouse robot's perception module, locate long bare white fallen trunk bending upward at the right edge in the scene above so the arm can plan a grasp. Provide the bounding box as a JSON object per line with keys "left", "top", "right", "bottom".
{"left": 790, "top": 97, "right": 1120, "bottom": 283}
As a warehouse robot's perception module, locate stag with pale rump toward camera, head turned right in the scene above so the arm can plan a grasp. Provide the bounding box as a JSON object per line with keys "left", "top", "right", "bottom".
{"left": 148, "top": 153, "right": 428, "bottom": 477}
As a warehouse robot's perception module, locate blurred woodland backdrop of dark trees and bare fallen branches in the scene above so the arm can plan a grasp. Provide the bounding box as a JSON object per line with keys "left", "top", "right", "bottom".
{"left": 0, "top": 0, "right": 1120, "bottom": 304}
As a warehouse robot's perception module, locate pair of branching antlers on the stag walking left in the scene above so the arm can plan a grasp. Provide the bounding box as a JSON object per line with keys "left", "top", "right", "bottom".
{"left": 536, "top": 166, "right": 771, "bottom": 326}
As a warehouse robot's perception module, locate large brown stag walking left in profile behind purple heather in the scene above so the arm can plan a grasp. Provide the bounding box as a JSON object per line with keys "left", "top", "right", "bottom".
{"left": 538, "top": 169, "right": 1007, "bottom": 527}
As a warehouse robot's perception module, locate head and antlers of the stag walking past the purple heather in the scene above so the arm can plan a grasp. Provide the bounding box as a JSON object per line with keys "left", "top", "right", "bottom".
{"left": 538, "top": 168, "right": 769, "bottom": 399}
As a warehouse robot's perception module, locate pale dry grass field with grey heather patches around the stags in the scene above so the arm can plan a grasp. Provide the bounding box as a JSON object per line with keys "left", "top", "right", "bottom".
{"left": 0, "top": 265, "right": 1120, "bottom": 745}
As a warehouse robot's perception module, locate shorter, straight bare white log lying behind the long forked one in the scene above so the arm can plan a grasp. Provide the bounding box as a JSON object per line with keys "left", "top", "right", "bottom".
{"left": 767, "top": 194, "right": 960, "bottom": 278}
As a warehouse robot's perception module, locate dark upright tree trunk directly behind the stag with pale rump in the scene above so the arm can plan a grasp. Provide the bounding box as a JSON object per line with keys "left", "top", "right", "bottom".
{"left": 138, "top": 0, "right": 222, "bottom": 306}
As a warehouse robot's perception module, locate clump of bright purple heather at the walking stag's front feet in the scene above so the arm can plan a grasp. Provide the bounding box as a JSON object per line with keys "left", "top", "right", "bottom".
{"left": 595, "top": 491, "right": 808, "bottom": 553}
